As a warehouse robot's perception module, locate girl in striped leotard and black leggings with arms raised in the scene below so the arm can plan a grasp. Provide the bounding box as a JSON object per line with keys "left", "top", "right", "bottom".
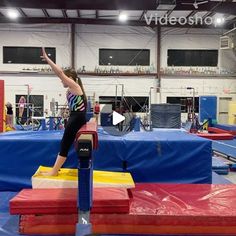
{"left": 41, "top": 48, "right": 87, "bottom": 176}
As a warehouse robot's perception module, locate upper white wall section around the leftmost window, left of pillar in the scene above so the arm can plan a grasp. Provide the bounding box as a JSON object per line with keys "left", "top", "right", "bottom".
{"left": 0, "top": 24, "right": 71, "bottom": 71}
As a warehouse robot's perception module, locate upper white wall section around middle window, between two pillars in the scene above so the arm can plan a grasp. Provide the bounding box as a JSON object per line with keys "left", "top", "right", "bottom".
{"left": 76, "top": 25, "right": 156, "bottom": 72}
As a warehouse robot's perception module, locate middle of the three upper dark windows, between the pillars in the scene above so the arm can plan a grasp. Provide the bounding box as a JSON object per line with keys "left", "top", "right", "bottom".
{"left": 99, "top": 49, "right": 150, "bottom": 66}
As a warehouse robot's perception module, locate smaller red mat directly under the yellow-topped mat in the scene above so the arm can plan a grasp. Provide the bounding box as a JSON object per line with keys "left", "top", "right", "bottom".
{"left": 10, "top": 188, "right": 130, "bottom": 214}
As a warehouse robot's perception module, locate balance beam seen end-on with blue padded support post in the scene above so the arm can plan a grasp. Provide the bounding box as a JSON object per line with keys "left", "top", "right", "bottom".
{"left": 75, "top": 119, "right": 98, "bottom": 236}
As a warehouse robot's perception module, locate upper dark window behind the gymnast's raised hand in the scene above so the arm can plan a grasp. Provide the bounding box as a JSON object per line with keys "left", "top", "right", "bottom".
{"left": 3, "top": 46, "right": 56, "bottom": 64}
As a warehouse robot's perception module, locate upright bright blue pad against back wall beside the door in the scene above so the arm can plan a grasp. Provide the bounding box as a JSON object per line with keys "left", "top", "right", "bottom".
{"left": 199, "top": 96, "right": 217, "bottom": 122}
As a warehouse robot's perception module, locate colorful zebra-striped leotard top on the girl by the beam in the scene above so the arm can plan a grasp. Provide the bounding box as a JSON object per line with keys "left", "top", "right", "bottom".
{"left": 66, "top": 90, "right": 85, "bottom": 112}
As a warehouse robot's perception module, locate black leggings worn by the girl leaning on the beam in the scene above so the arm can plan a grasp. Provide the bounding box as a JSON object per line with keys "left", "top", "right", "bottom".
{"left": 59, "top": 112, "right": 86, "bottom": 157}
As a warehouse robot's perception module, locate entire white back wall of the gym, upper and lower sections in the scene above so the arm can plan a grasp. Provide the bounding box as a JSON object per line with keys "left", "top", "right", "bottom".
{"left": 0, "top": 24, "right": 236, "bottom": 122}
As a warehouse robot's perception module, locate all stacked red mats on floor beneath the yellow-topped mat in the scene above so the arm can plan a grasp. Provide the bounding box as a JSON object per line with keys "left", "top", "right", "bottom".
{"left": 10, "top": 184, "right": 236, "bottom": 235}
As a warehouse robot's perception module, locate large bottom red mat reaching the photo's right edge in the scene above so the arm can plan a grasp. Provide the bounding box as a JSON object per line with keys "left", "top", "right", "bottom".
{"left": 19, "top": 184, "right": 236, "bottom": 235}
